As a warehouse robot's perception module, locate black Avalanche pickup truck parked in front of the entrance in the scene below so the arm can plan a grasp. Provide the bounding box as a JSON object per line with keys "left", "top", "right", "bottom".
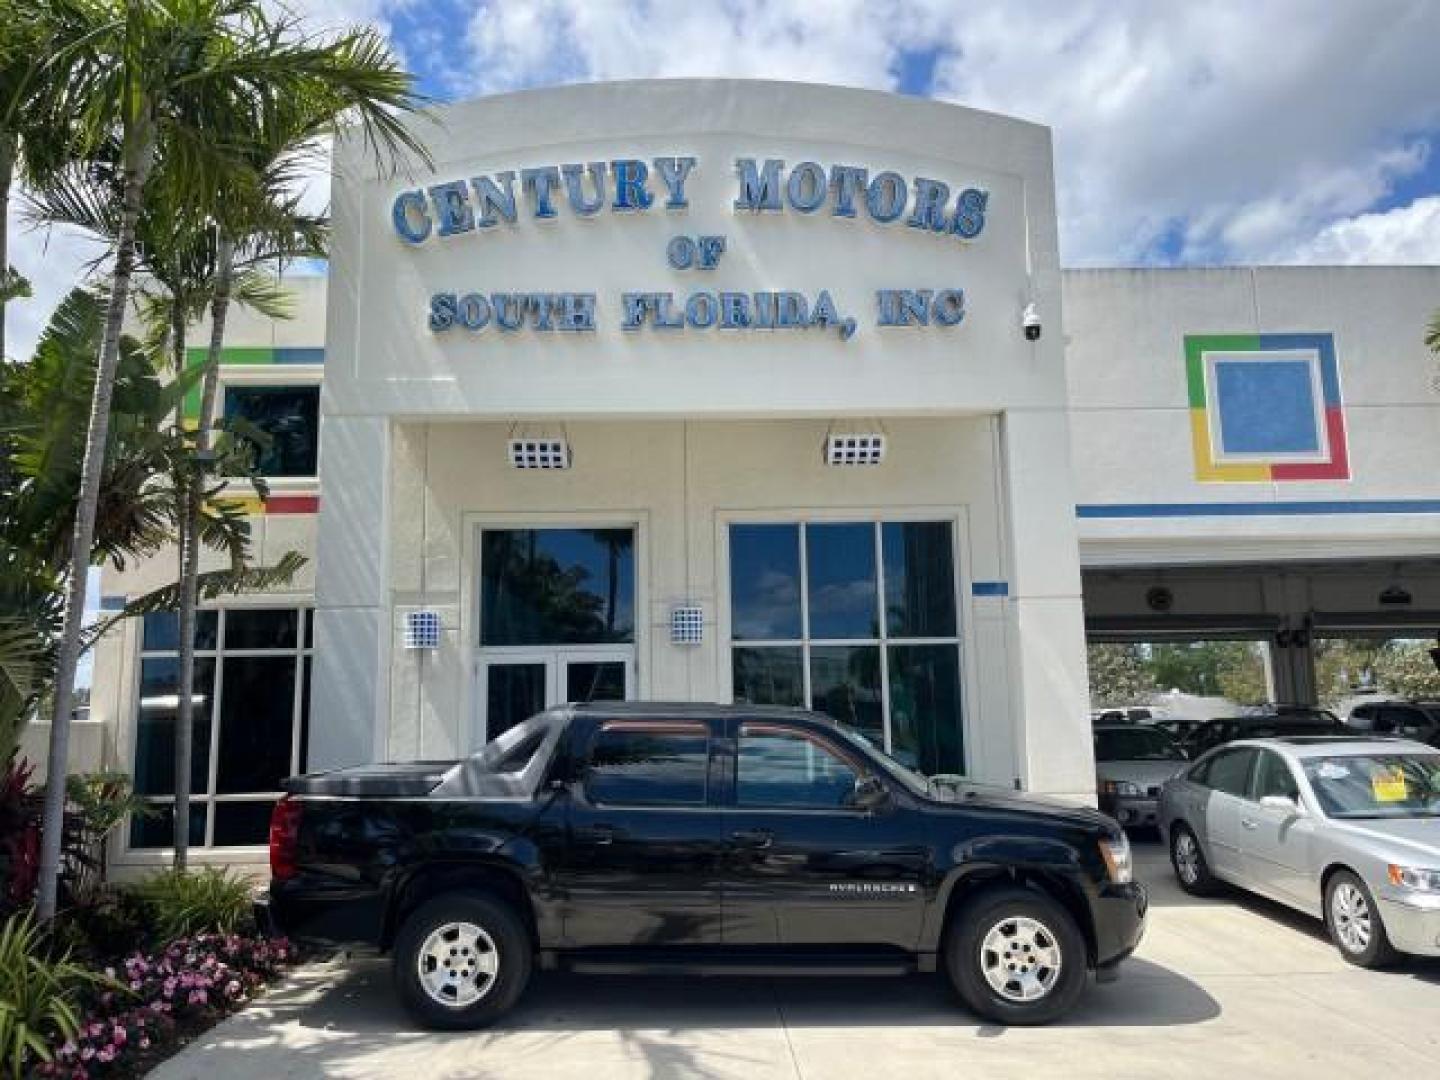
{"left": 262, "top": 703, "right": 1146, "bottom": 1028}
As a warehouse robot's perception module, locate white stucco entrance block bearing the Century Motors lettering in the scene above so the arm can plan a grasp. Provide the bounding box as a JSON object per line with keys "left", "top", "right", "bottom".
{"left": 311, "top": 81, "right": 1092, "bottom": 798}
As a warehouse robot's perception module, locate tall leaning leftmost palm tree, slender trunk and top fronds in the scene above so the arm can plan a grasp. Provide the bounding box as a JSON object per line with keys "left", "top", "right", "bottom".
{"left": 36, "top": 0, "right": 418, "bottom": 920}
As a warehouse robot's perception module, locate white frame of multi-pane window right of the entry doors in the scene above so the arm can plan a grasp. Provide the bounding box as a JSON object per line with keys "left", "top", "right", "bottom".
{"left": 714, "top": 507, "right": 978, "bottom": 769}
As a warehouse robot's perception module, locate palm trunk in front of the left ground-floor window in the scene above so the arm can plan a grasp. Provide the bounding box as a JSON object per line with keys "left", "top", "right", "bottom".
{"left": 174, "top": 236, "right": 235, "bottom": 870}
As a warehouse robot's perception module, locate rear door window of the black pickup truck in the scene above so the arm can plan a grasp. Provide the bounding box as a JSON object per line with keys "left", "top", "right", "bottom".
{"left": 585, "top": 723, "right": 710, "bottom": 806}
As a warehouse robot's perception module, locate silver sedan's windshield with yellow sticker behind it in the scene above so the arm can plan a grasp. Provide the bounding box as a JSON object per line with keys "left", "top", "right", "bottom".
{"left": 1305, "top": 753, "right": 1440, "bottom": 818}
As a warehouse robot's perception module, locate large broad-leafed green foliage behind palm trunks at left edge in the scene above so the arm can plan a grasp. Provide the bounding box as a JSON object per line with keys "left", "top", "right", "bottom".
{"left": 0, "top": 280, "right": 305, "bottom": 817}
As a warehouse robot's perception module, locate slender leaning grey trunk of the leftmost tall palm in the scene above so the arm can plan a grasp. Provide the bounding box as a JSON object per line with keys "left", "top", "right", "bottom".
{"left": 35, "top": 122, "right": 156, "bottom": 923}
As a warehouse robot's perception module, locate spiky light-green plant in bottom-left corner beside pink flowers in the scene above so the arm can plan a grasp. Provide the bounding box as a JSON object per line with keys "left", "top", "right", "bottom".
{"left": 0, "top": 912, "right": 109, "bottom": 1077}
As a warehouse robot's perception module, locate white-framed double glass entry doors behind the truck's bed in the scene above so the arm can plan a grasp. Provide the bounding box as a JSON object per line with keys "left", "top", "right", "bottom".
{"left": 475, "top": 645, "right": 635, "bottom": 746}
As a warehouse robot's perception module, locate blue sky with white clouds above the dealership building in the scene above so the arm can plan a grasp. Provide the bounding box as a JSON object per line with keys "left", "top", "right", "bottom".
{"left": 9, "top": 0, "right": 1440, "bottom": 356}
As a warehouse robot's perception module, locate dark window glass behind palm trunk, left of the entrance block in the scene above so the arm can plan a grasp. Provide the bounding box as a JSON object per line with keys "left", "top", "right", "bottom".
{"left": 130, "top": 608, "right": 312, "bottom": 848}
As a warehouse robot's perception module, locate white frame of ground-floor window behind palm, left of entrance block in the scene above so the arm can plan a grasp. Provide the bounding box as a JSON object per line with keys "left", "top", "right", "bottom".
{"left": 117, "top": 595, "right": 315, "bottom": 864}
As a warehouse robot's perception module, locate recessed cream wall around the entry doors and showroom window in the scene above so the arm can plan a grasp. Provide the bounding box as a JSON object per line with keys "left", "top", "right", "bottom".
{"left": 382, "top": 418, "right": 1020, "bottom": 785}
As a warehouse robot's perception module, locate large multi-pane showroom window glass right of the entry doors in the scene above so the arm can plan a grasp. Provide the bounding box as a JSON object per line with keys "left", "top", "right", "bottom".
{"left": 730, "top": 521, "right": 965, "bottom": 775}
